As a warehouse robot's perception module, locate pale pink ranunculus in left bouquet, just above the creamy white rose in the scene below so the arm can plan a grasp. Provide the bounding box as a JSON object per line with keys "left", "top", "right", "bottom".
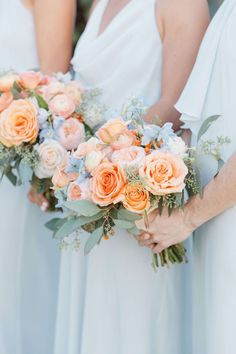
{"left": 58, "top": 118, "right": 85, "bottom": 150}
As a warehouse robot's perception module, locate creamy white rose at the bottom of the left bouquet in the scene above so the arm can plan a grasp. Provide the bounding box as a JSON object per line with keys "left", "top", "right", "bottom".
{"left": 34, "top": 139, "right": 67, "bottom": 178}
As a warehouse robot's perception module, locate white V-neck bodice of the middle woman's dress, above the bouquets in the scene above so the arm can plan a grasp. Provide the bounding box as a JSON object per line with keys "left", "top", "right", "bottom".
{"left": 72, "top": 0, "right": 162, "bottom": 110}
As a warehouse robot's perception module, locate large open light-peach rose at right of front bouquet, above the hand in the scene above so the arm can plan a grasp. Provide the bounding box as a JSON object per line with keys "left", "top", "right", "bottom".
{"left": 139, "top": 151, "right": 188, "bottom": 196}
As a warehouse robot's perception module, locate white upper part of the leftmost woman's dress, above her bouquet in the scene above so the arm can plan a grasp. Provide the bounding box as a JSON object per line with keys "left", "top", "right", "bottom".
{"left": 0, "top": 0, "right": 39, "bottom": 72}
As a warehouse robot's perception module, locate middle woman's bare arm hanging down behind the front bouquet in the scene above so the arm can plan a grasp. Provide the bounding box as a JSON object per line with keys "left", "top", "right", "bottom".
{"left": 146, "top": 0, "right": 209, "bottom": 129}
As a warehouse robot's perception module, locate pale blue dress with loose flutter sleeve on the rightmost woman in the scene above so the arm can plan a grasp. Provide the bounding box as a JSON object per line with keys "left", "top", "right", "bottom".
{"left": 176, "top": 0, "right": 236, "bottom": 354}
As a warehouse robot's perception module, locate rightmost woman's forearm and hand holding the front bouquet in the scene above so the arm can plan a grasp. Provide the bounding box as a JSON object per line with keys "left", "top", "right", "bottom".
{"left": 138, "top": 153, "right": 236, "bottom": 252}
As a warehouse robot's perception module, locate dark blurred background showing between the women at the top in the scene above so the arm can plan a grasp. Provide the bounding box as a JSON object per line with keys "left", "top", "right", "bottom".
{"left": 74, "top": 0, "right": 223, "bottom": 43}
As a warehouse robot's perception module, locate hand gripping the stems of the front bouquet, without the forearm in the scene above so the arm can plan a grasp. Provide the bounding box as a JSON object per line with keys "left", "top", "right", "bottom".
{"left": 136, "top": 209, "right": 195, "bottom": 253}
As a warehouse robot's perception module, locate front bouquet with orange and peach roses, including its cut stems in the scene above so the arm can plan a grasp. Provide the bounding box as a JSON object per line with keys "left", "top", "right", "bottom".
{"left": 46, "top": 105, "right": 200, "bottom": 268}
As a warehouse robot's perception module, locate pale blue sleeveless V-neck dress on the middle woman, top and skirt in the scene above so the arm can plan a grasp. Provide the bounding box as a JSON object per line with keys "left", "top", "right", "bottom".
{"left": 54, "top": 0, "right": 191, "bottom": 354}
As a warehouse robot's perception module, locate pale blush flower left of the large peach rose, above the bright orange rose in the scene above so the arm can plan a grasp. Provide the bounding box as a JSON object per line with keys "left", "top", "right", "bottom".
{"left": 111, "top": 146, "right": 146, "bottom": 166}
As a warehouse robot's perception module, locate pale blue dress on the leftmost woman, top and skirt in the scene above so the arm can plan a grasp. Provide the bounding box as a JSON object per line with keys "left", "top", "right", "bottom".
{"left": 0, "top": 0, "right": 59, "bottom": 354}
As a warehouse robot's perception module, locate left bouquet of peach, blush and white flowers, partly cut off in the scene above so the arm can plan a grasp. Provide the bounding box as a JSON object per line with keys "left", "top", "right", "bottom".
{"left": 0, "top": 71, "right": 101, "bottom": 210}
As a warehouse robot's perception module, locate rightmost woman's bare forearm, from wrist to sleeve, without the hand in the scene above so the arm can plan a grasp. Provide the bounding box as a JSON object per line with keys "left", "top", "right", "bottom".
{"left": 185, "top": 153, "right": 236, "bottom": 229}
